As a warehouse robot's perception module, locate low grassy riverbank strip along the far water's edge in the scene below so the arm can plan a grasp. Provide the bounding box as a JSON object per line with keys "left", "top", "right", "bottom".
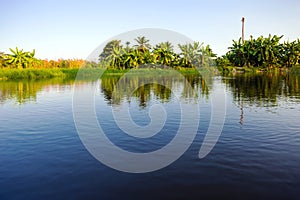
{"left": 0, "top": 65, "right": 300, "bottom": 81}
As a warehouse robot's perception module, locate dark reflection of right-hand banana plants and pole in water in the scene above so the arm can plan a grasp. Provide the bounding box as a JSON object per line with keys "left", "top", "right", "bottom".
{"left": 223, "top": 73, "right": 300, "bottom": 124}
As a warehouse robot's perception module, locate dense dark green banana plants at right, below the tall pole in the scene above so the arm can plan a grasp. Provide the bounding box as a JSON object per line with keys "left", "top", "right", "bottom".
{"left": 217, "top": 35, "right": 300, "bottom": 69}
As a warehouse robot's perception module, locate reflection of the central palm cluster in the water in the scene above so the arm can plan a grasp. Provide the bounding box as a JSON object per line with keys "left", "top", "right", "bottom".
{"left": 101, "top": 72, "right": 212, "bottom": 107}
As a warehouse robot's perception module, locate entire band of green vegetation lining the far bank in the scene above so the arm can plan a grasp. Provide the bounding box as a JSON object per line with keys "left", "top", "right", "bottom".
{"left": 0, "top": 35, "right": 300, "bottom": 80}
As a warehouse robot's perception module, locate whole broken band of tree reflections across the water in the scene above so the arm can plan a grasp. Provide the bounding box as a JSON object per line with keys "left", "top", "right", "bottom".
{"left": 0, "top": 74, "right": 300, "bottom": 108}
